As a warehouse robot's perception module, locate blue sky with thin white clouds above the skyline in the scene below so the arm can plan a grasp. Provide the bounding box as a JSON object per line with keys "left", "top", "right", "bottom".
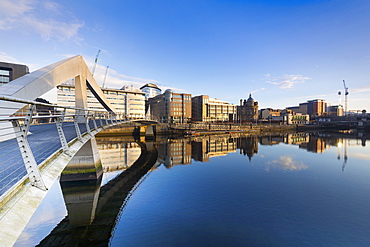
{"left": 0, "top": 0, "right": 370, "bottom": 111}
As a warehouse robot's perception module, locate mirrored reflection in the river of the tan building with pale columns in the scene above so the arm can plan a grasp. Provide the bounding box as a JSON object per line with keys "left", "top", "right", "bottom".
{"left": 191, "top": 136, "right": 237, "bottom": 162}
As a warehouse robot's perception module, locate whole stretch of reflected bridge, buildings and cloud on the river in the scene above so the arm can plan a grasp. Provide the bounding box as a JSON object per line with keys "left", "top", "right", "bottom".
{"left": 33, "top": 133, "right": 370, "bottom": 246}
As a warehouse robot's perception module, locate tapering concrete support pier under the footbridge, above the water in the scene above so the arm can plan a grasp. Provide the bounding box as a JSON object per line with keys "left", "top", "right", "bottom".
{"left": 60, "top": 137, "right": 103, "bottom": 182}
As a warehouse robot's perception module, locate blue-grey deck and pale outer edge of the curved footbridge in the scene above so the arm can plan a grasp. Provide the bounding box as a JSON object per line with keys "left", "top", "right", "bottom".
{"left": 0, "top": 118, "right": 136, "bottom": 246}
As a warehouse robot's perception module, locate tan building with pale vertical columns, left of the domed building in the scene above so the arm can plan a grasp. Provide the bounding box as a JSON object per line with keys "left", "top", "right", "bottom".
{"left": 191, "top": 95, "right": 236, "bottom": 122}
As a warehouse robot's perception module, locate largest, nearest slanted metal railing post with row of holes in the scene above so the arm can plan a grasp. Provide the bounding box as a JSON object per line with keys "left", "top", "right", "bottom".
{"left": 12, "top": 105, "right": 46, "bottom": 190}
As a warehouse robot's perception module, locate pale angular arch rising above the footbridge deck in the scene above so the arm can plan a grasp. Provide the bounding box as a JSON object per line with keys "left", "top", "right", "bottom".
{"left": 0, "top": 55, "right": 115, "bottom": 116}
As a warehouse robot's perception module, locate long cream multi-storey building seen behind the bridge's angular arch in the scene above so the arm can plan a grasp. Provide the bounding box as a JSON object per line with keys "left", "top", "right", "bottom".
{"left": 57, "top": 82, "right": 145, "bottom": 117}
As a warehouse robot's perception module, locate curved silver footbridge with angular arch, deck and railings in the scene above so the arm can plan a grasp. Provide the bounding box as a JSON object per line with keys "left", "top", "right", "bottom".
{"left": 0, "top": 56, "right": 155, "bottom": 246}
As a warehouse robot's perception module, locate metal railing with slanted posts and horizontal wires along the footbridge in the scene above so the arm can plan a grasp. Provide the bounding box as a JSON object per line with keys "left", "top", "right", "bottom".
{"left": 0, "top": 96, "right": 134, "bottom": 197}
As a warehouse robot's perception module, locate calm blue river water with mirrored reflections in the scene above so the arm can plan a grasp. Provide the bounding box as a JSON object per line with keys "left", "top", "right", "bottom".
{"left": 16, "top": 133, "right": 370, "bottom": 246}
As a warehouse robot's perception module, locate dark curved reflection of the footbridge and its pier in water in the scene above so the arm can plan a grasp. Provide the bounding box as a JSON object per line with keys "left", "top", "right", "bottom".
{"left": 39, "top": 143, "right": 158, "bottom": 246}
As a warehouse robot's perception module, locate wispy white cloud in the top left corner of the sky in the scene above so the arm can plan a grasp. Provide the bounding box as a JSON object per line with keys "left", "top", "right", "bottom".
{"left": 0, "top": 0, "right": 84, "bottom": 42}
